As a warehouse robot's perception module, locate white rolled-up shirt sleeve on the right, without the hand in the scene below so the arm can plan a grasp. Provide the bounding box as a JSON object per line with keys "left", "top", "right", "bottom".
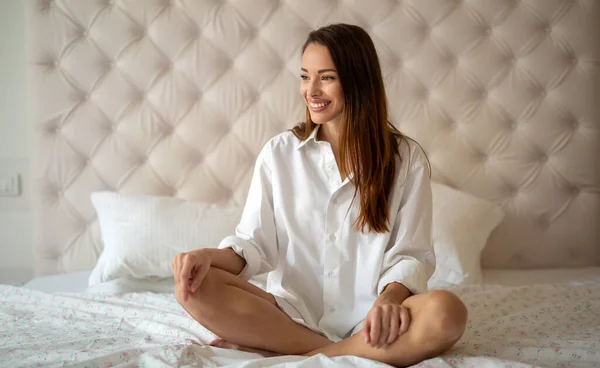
{"left": 377, "top": 148, "right": 435, "bottom": 295}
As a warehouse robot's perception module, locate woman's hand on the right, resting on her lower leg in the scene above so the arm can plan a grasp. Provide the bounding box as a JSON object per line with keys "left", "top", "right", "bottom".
{"left": 362, "top": 302, "right": 410, "bottom": 348}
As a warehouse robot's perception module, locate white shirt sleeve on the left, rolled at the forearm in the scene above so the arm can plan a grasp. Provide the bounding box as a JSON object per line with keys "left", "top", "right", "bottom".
{"left": 218, "top": 142, "right": 278, "bottom": 280}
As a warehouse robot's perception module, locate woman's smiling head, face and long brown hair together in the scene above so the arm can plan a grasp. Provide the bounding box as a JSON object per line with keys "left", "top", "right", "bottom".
{"left": 292, "top": 24, "right": 403, "bottom": 232}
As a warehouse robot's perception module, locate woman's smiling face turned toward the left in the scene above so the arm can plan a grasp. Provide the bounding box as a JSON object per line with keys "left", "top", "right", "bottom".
{"left": 300, "top": 43, "right": 344, "bottom": 124}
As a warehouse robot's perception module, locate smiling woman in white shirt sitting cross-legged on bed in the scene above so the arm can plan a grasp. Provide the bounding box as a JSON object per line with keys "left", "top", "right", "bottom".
{"left": 172, "top": 24, "right": 467, "bottom": 366}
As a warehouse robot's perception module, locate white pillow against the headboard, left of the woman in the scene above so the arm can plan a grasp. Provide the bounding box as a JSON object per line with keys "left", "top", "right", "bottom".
{"left": 88, "top": 191, "right": 243, "bottom": 286}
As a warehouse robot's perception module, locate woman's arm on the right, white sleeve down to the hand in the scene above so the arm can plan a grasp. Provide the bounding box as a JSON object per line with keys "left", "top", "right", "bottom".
{"left": 362, "top": 144, "right": 435, "bottom": 347}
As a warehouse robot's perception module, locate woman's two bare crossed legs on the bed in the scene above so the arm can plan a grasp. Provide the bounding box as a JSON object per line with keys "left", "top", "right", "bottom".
{"left": 176, "top": 268, "right": 467, "bottom": 366}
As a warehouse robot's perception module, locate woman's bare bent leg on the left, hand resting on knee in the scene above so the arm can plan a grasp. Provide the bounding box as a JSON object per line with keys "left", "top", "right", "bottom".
{"left": 175, "top": 267, "right": 332, "bottom": 354}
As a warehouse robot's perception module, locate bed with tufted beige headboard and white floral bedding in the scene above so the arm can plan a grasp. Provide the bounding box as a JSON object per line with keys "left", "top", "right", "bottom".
{"left": 0, "top": 0, "right": 600, "bottom": 367}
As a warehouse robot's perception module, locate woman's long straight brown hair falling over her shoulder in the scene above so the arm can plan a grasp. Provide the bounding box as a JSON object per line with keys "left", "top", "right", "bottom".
{"left": 292, "top": 24, "right": 404, "bottom": 233}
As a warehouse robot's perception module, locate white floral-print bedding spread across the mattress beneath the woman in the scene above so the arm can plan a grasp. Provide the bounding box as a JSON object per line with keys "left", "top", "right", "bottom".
{"left": 0, "top": 283, "right": 600, "bottom": 367}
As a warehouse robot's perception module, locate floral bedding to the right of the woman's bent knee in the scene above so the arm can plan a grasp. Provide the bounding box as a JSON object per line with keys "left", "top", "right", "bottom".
{"left": 419, "top": 282, "right": 600, "bottom": 367}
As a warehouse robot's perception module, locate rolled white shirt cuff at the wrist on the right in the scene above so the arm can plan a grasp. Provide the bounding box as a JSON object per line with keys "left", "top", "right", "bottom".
{"left": 377, "top": 259, "right": 428, "bottom": 296}
